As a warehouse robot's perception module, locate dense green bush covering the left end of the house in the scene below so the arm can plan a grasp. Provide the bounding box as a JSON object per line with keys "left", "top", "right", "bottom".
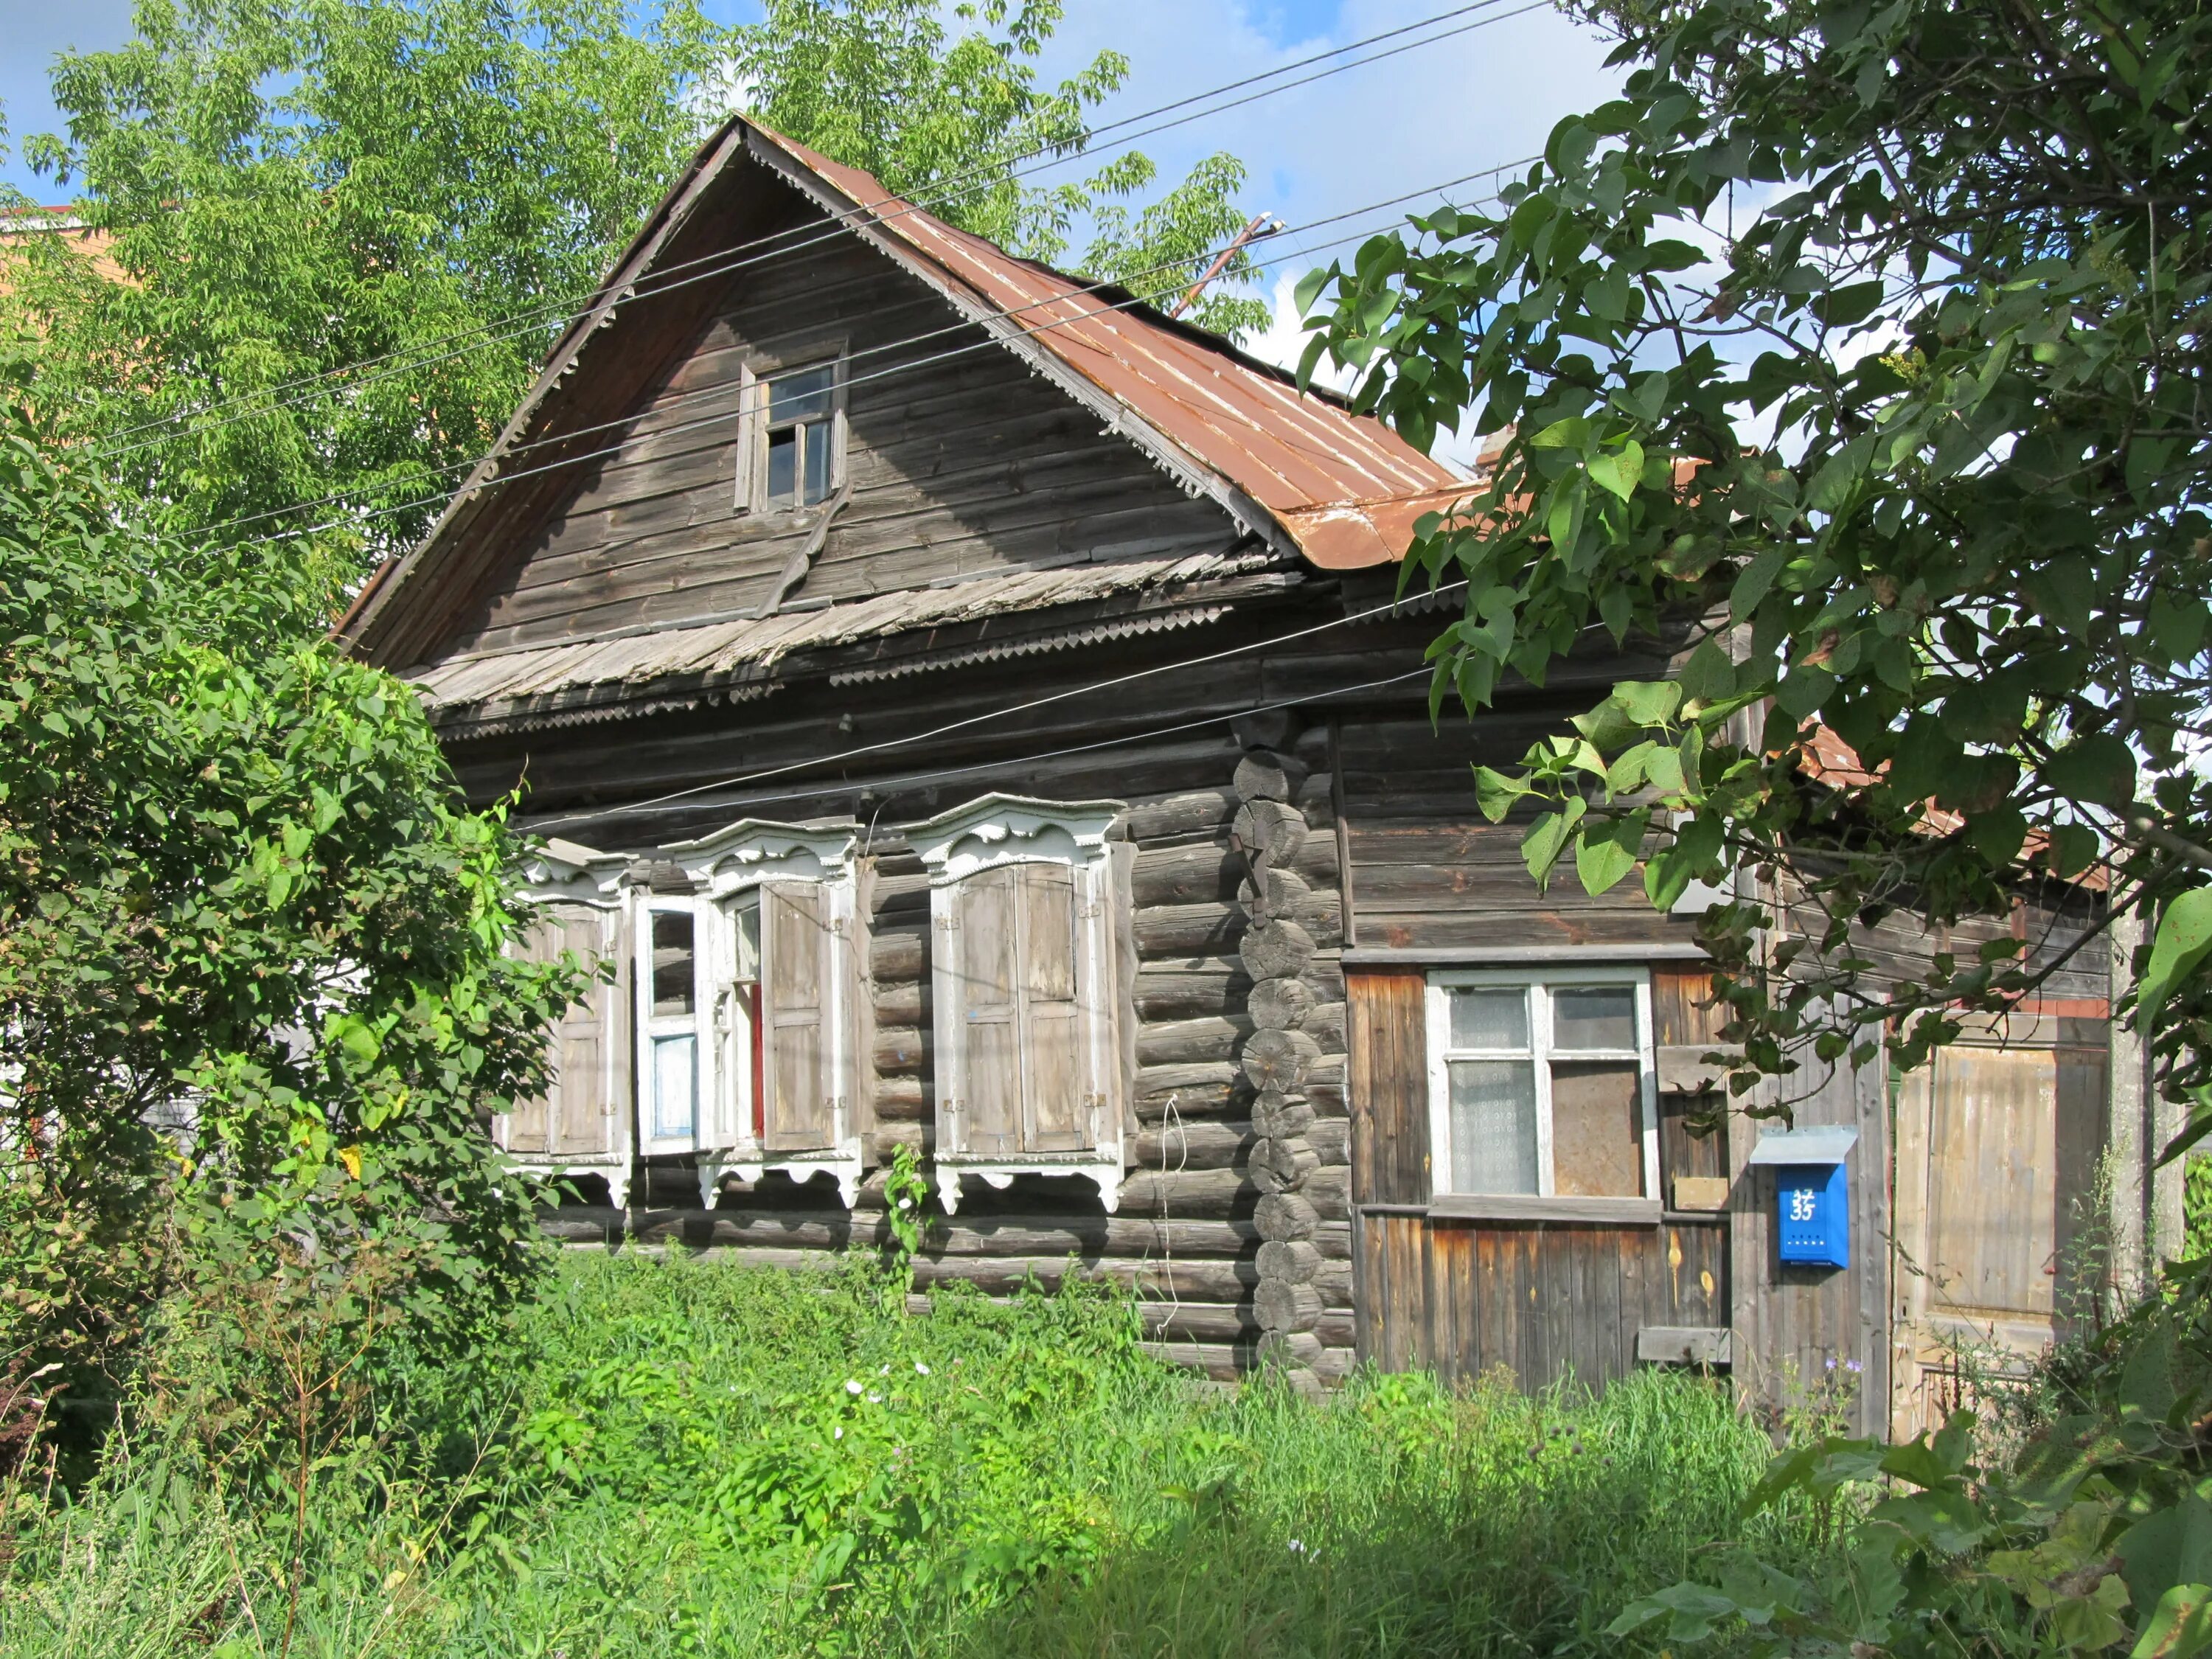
{"left": 0, "top": 380, "right": 577, "bottom": 1433}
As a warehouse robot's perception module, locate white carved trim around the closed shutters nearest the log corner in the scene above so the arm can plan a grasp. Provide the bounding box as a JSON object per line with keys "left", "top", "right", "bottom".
{"left": 907, "top": 794, "right": 1128, "bottom": 1214}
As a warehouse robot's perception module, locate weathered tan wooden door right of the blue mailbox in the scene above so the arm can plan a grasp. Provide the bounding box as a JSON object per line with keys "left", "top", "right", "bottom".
{"left": 1891, "top": 1040, "right": 2095, "bottom": 1438}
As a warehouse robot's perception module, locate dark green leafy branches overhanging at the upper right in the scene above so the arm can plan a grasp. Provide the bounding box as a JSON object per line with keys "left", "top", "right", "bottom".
{"left": 1303, "top": 0, "right": 2212, "bottom": 1130}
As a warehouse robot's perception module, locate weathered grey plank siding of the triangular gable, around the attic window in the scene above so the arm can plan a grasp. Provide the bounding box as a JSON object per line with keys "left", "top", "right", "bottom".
{"left": 440, "top": 212, "right": 1234, "bottom": 655}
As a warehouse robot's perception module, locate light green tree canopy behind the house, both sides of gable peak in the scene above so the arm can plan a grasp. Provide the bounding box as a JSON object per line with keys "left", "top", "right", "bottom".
{"left": 0, "top": 0, "right": 1265, "bottom": 608}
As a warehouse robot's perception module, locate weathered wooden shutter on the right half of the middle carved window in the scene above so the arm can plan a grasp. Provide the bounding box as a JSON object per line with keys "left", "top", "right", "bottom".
{"left": 761, "top": 880, "right": 841, "bottom": 1152}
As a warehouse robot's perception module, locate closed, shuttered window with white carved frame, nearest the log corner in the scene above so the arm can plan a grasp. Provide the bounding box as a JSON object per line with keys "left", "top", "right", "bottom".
{"left": 907, "top": 794, "right": 1126, "bottom": 1210}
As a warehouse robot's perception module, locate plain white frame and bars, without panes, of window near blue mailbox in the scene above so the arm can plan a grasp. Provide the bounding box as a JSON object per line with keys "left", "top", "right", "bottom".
{"left": 1427, "top": 967, "right": 1661, "bottom": 1221}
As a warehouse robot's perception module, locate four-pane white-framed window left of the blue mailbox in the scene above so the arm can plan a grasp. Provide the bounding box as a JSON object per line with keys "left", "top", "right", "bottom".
{"left": 1429, "top": 969, "right": 1659, "bottom": 1199}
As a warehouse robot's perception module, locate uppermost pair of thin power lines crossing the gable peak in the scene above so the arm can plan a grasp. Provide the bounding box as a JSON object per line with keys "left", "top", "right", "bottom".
{"left": 88, "top": 0, "right": 1548, "bottom": 460}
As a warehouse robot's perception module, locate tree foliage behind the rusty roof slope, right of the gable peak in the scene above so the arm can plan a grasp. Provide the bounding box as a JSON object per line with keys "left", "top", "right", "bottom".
{"left": 734, "top": 0, "right": 1270, "bottom": 338}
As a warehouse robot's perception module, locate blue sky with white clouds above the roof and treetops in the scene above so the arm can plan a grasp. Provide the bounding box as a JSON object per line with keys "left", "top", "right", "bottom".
{"left": 0, "top": 0, "right": 1613, "bottom": 456}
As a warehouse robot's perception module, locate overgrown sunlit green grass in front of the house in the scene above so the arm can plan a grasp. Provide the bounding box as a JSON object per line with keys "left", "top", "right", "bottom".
{"left": 0, "top": 1256, "right": 1792, "bottom": 1659}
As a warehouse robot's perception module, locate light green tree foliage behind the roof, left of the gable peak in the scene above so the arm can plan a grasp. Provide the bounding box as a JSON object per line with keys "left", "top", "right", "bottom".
{"left": 0, "top": 0, "right": 743, "bottom": 611}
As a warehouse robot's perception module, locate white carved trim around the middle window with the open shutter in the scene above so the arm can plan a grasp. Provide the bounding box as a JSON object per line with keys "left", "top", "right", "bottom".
{"left": 666, "top": 818, "right": 865, "bottom": 1210}
